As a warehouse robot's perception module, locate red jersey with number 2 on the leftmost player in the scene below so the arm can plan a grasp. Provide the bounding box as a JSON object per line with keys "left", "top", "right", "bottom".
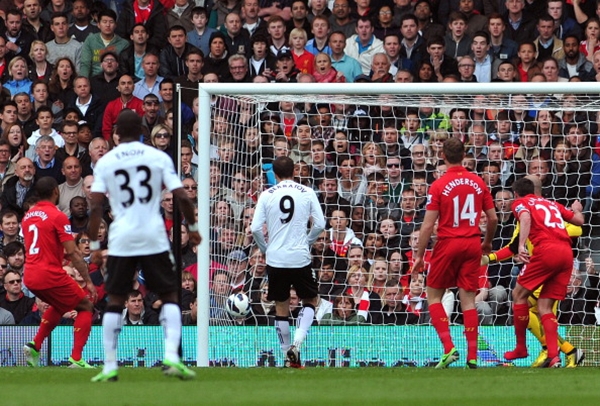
{"left": 22, "top": 201, "right": 73, "bottom": 290}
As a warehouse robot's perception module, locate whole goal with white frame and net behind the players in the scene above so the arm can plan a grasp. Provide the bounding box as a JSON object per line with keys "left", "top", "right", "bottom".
{"left": 182, "top": 83, "right": 600, "bottom": 366}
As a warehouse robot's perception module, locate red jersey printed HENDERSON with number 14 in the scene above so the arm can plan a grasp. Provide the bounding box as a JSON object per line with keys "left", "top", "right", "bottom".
{"left": 426, "top": 166, "right": 494, "bottom": 238}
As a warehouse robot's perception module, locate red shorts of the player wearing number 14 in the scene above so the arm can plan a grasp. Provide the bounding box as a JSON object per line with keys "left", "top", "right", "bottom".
{"left": 427, "top": 237, "right": 481, "bottom": 292}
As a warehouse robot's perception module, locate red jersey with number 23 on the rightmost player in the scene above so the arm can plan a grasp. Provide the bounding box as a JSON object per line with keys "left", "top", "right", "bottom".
{"left": 512, "top": 195, "right": 575, "bottom": 247}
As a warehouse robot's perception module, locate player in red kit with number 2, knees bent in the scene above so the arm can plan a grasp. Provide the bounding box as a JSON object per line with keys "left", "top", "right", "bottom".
{"left": 23, "top": 177, "right": 96, "bottom": 368}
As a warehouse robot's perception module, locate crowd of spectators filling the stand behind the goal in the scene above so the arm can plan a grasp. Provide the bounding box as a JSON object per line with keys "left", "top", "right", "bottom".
{"left": 0, "top": 0, "right": 600, "bottom": 325}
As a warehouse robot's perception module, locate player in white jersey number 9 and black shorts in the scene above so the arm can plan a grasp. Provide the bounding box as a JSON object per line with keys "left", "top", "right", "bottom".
{"left": 251, "top": 157, "right": 325, "bottom": 368}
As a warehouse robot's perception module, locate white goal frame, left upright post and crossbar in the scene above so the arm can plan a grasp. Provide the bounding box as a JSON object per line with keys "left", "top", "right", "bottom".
{"left": 197, "top": 82, "right": 600, "bottom": 366}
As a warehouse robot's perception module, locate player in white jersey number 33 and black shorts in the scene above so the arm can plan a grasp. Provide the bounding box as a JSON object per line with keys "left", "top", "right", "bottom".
{"left": 89, "top": 110, "right": 200, "bottom": 382}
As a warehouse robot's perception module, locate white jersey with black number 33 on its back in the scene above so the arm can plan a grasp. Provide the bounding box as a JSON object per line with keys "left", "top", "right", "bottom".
{"left": 92, "top": 141, "right": 182, "bottom": 257}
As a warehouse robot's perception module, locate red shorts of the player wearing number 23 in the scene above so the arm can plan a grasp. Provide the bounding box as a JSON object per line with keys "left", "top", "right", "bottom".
{"left": 517, "top": 244, "right": 573, "bottom": 300}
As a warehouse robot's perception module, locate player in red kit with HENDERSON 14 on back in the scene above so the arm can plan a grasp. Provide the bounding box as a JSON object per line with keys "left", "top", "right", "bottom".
{"left": 412, "top": 138, "right": 498, "bottom": 368}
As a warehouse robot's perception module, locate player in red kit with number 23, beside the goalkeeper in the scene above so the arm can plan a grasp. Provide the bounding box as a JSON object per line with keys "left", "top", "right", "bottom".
{"left": 504, "top": 178, "right": 584, "bottom": 368}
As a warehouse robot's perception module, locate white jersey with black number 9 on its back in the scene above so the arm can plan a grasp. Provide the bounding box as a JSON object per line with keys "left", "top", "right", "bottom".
{"left": 251, "top": 180, "right": 325, "bottom": 268}
